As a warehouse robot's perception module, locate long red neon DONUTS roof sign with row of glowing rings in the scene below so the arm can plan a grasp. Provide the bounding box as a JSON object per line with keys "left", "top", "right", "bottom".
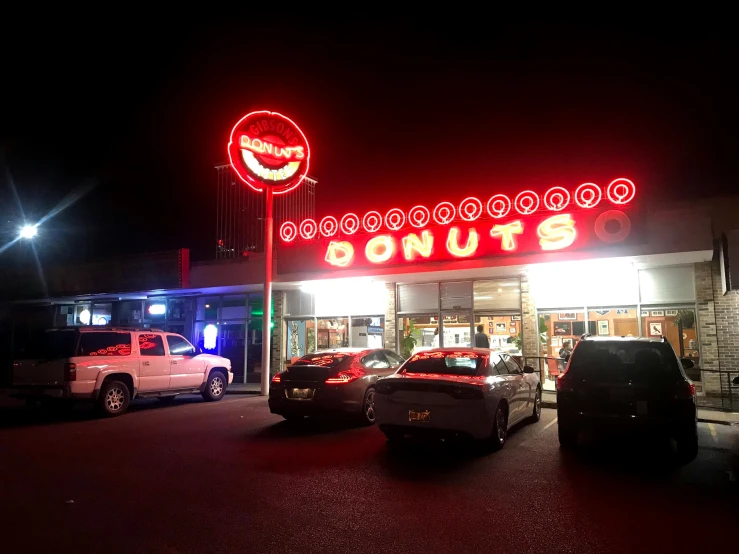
{"left": 280, "top": 178, "right": 636, "bottom": 268}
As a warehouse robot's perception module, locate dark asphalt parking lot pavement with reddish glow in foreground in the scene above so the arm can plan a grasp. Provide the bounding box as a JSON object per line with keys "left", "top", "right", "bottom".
{"left": 0, "top": 395, "right": 739, "bottom": 554}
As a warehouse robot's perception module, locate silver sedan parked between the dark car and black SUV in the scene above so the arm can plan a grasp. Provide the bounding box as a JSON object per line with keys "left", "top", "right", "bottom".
{"left": 375, "top": 348, "right": 541, "bottom": 450}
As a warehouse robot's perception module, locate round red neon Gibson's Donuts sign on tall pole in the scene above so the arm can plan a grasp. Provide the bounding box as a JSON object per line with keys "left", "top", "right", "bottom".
{"left": 227, "top": 110, "right": 310, "bottom": 194}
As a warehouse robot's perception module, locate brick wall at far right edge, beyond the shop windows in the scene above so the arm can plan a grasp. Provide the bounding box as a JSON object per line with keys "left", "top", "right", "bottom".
{"left": 711, "top": 260, "right": 739, "bottom": 392}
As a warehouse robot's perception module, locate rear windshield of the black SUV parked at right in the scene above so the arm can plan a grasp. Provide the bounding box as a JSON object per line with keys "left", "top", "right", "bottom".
{"left": 567, "top": 341, "right": 680, "bottom": 382}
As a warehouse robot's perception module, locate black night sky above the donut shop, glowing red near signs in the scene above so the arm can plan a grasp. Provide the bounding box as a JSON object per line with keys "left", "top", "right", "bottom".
{"left": 0, "top": 19, "right": 739, "bottom": 264}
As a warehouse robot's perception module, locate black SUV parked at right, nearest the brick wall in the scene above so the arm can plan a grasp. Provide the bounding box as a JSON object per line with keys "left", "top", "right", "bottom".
{"left": 557, "top": 335, "right": 698, "bottom": 461}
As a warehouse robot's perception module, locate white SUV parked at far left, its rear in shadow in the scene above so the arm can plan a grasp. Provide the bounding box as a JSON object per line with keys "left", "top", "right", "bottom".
{"left": 11, "top": 327, "right": 233, "bottom": 416}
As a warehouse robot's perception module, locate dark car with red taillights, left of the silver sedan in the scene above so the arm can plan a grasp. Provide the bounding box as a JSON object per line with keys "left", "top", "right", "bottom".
{"left": 269, "top": 348, "right": 403, "bottom": 425}
